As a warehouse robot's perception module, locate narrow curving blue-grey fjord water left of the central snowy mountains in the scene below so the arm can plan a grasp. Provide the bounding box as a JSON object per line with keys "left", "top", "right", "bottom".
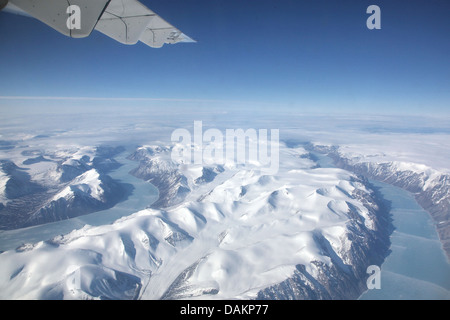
{"left": 0, "top": 152, "right": 158, "bottom": 251}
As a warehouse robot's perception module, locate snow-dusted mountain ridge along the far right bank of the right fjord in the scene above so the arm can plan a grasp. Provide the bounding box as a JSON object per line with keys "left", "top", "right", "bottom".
{"left": 310, "top": 145, "right": 450, "bottom": 259}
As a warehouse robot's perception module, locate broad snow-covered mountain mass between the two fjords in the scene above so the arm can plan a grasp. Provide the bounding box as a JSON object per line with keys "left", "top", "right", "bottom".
{"left": 0, "top": 142, "right": 389, "bottom": 299}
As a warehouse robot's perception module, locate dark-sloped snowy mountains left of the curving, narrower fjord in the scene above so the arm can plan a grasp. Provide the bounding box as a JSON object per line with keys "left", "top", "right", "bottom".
{"left": 0, "top": 146, "right": 129, "bottom": 229}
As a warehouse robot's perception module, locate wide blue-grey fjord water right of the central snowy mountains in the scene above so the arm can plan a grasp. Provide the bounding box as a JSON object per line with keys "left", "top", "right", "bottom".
{"left": 314, "top": 153, "right": 450, "bottom": 300}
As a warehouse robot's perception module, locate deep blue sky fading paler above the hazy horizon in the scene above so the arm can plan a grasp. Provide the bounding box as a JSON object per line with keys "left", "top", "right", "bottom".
{"left": 0, "top": 0, "right": 450, "bottom": 114}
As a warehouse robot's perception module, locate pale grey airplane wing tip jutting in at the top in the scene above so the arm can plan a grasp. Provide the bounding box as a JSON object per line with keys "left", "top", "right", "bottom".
{"left": 0, "top": 0, "right": 195, "bottom": 48}
